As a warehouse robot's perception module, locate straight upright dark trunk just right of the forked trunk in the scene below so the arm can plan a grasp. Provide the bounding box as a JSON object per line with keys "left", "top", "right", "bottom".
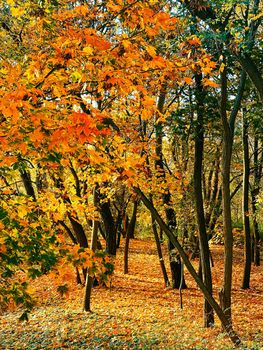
{"left": 242, "top": 109, "right": 251, "bottom": 289}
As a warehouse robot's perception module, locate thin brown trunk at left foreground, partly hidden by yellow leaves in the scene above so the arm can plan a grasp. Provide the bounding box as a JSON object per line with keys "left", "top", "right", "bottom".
{"left": 83, "top": 189, "right": 99, "bottom": 312}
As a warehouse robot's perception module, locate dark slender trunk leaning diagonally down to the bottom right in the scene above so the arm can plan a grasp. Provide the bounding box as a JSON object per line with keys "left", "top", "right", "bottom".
{"left": 136, "top": 187, "right": 241, "bottom": 345}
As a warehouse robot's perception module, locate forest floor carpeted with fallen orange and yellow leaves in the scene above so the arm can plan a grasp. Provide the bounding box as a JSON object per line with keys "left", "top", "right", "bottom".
{"left": 0, "top": 240, "right": 263, "bottom": 350}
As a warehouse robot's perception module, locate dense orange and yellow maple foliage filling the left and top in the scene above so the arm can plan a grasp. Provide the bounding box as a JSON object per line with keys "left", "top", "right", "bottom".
{"left": 0, "top": 0, "right": 262, "bottom": 346}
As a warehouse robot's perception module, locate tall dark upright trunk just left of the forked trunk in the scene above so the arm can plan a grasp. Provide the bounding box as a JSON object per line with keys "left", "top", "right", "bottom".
{"left": 194, "top": 74, "right": 214, "bottom": 327}
